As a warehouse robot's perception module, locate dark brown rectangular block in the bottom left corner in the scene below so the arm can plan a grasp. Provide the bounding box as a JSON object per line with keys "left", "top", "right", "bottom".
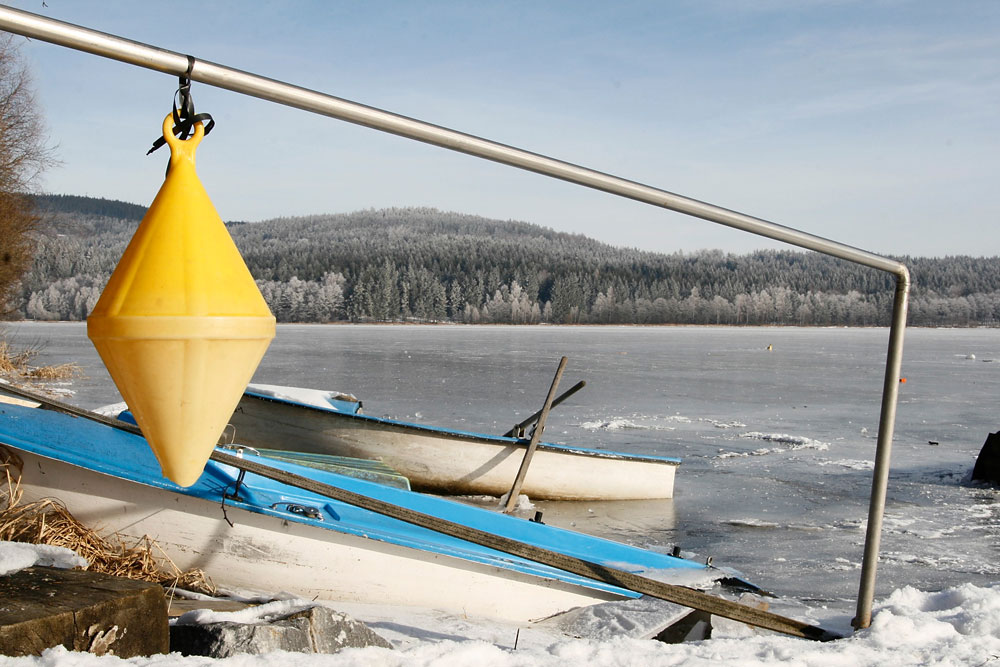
{"left": 0, "top": 567, "right": 170, "bottom": 658}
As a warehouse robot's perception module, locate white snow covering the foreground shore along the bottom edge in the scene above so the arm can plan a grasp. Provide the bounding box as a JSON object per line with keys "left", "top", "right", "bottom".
{"left": 0, "top": 542, "right": 1000, "bottom": 667}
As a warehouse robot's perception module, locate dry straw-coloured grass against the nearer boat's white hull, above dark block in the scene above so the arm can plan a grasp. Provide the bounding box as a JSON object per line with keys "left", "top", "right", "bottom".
{"left": 0, "top": 447, "right": 216, "bottom": 595}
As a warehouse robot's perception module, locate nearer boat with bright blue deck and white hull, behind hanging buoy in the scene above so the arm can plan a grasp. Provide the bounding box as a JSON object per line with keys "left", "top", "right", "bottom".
{"left": 0, "top": 405, "right": 717, "bottom": 622}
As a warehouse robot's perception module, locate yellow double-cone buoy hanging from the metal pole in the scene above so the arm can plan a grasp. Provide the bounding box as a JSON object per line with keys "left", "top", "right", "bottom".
{"left": 87, "top": 115, "right": 275, "bottom": 486}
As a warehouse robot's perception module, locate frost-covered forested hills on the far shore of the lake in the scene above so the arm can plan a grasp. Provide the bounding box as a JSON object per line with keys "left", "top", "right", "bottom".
{"left": 13, "top": 196, "right": 1000, "bottom": 326}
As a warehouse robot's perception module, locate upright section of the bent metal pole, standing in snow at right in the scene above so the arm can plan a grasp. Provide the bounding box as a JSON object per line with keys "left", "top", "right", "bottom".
{"left": 851, "top": 270, "right": 910, "bottom": 630}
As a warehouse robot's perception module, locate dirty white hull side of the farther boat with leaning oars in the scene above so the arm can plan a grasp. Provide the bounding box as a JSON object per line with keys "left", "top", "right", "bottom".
{"left": 231, "top": 396, "right": 677, "bottom": 500}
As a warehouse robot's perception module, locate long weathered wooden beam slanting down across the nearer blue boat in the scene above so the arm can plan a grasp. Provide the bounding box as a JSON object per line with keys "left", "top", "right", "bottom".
{"left": 0, "top": 384, "right": 841, "bottom": 641}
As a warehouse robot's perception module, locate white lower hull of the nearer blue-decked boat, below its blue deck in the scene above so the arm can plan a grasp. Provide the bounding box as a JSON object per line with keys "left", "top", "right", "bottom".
{"left": 14, "top": 449, "right": 622, "bottom": 623}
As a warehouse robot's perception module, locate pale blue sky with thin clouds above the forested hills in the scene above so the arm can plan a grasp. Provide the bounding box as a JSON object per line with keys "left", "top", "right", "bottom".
{"left": 11, "top": 0, "right": 1000, "bottom": 256}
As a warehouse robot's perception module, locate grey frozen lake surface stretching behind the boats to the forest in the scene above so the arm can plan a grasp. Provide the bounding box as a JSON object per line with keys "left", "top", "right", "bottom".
{"left": 7, "top": 323, "right": 1000, "bottom": 628}
